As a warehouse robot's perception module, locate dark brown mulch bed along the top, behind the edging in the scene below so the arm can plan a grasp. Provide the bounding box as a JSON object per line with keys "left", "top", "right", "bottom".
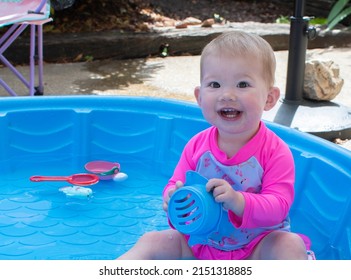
{"left": 45, "top": 0, "right": 293, "bottom": 33}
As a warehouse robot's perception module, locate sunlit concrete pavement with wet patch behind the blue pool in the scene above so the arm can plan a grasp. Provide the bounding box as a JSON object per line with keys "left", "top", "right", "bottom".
{"left": 0, "top": 48, "right": 351, "bottom": 143}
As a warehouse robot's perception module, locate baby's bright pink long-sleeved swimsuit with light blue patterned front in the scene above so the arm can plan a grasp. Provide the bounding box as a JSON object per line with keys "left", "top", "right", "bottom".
{"left": 163, "top": 122, "right": 310, "bottom": 259}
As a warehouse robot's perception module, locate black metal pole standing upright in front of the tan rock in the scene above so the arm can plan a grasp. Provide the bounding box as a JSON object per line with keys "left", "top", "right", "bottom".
{"left": 284, "top": 0, "right": 309, "bottom": 103}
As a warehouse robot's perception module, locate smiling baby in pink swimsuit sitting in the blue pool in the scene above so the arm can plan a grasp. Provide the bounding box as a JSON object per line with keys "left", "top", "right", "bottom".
{"left": 120, "top": 31, "right": 309, "bottom": 260}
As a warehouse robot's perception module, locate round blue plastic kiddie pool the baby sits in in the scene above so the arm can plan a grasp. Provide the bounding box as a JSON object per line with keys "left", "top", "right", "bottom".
{"left": 0, "top": 96, "right": 351, "bottom": 260}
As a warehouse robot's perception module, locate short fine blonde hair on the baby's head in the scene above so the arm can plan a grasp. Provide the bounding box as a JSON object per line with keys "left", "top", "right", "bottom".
{"left": 200, "top": 31, "right": 276, "bottom": 86}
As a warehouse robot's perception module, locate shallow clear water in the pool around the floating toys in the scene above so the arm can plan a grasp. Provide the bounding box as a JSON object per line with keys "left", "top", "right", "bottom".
{"left": 0, "top": 156, "right": 168, "bottom": 260}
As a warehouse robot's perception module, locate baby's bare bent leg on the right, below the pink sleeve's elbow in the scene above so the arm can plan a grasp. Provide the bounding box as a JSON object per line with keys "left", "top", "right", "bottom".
{"left": 249, "top": 231, "right": 307, "bottom": 260}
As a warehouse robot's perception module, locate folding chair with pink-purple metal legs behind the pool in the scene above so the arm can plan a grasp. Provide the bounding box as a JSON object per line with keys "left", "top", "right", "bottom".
{"left": 0, "top": 0, "right": 52, "bottom": 96}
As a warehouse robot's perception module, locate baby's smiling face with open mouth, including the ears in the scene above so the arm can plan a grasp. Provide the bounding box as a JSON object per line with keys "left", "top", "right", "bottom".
{"left": 195, "top": 55, "right": 278, "bottom": 137}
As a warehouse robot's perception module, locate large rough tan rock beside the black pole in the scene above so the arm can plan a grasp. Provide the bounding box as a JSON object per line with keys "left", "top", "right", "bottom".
{"left": 303, "top": 59, "right": 344, "bottom": 101}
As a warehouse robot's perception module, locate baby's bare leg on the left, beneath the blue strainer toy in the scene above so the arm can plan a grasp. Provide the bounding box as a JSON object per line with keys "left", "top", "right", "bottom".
{"left": 118, "top": 229, "right": 193, "bottom": 260}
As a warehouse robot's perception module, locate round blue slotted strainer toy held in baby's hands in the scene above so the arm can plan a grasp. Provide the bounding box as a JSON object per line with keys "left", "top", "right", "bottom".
{"left": 168, "top": 171, "right": 222, "bottom": 244}
